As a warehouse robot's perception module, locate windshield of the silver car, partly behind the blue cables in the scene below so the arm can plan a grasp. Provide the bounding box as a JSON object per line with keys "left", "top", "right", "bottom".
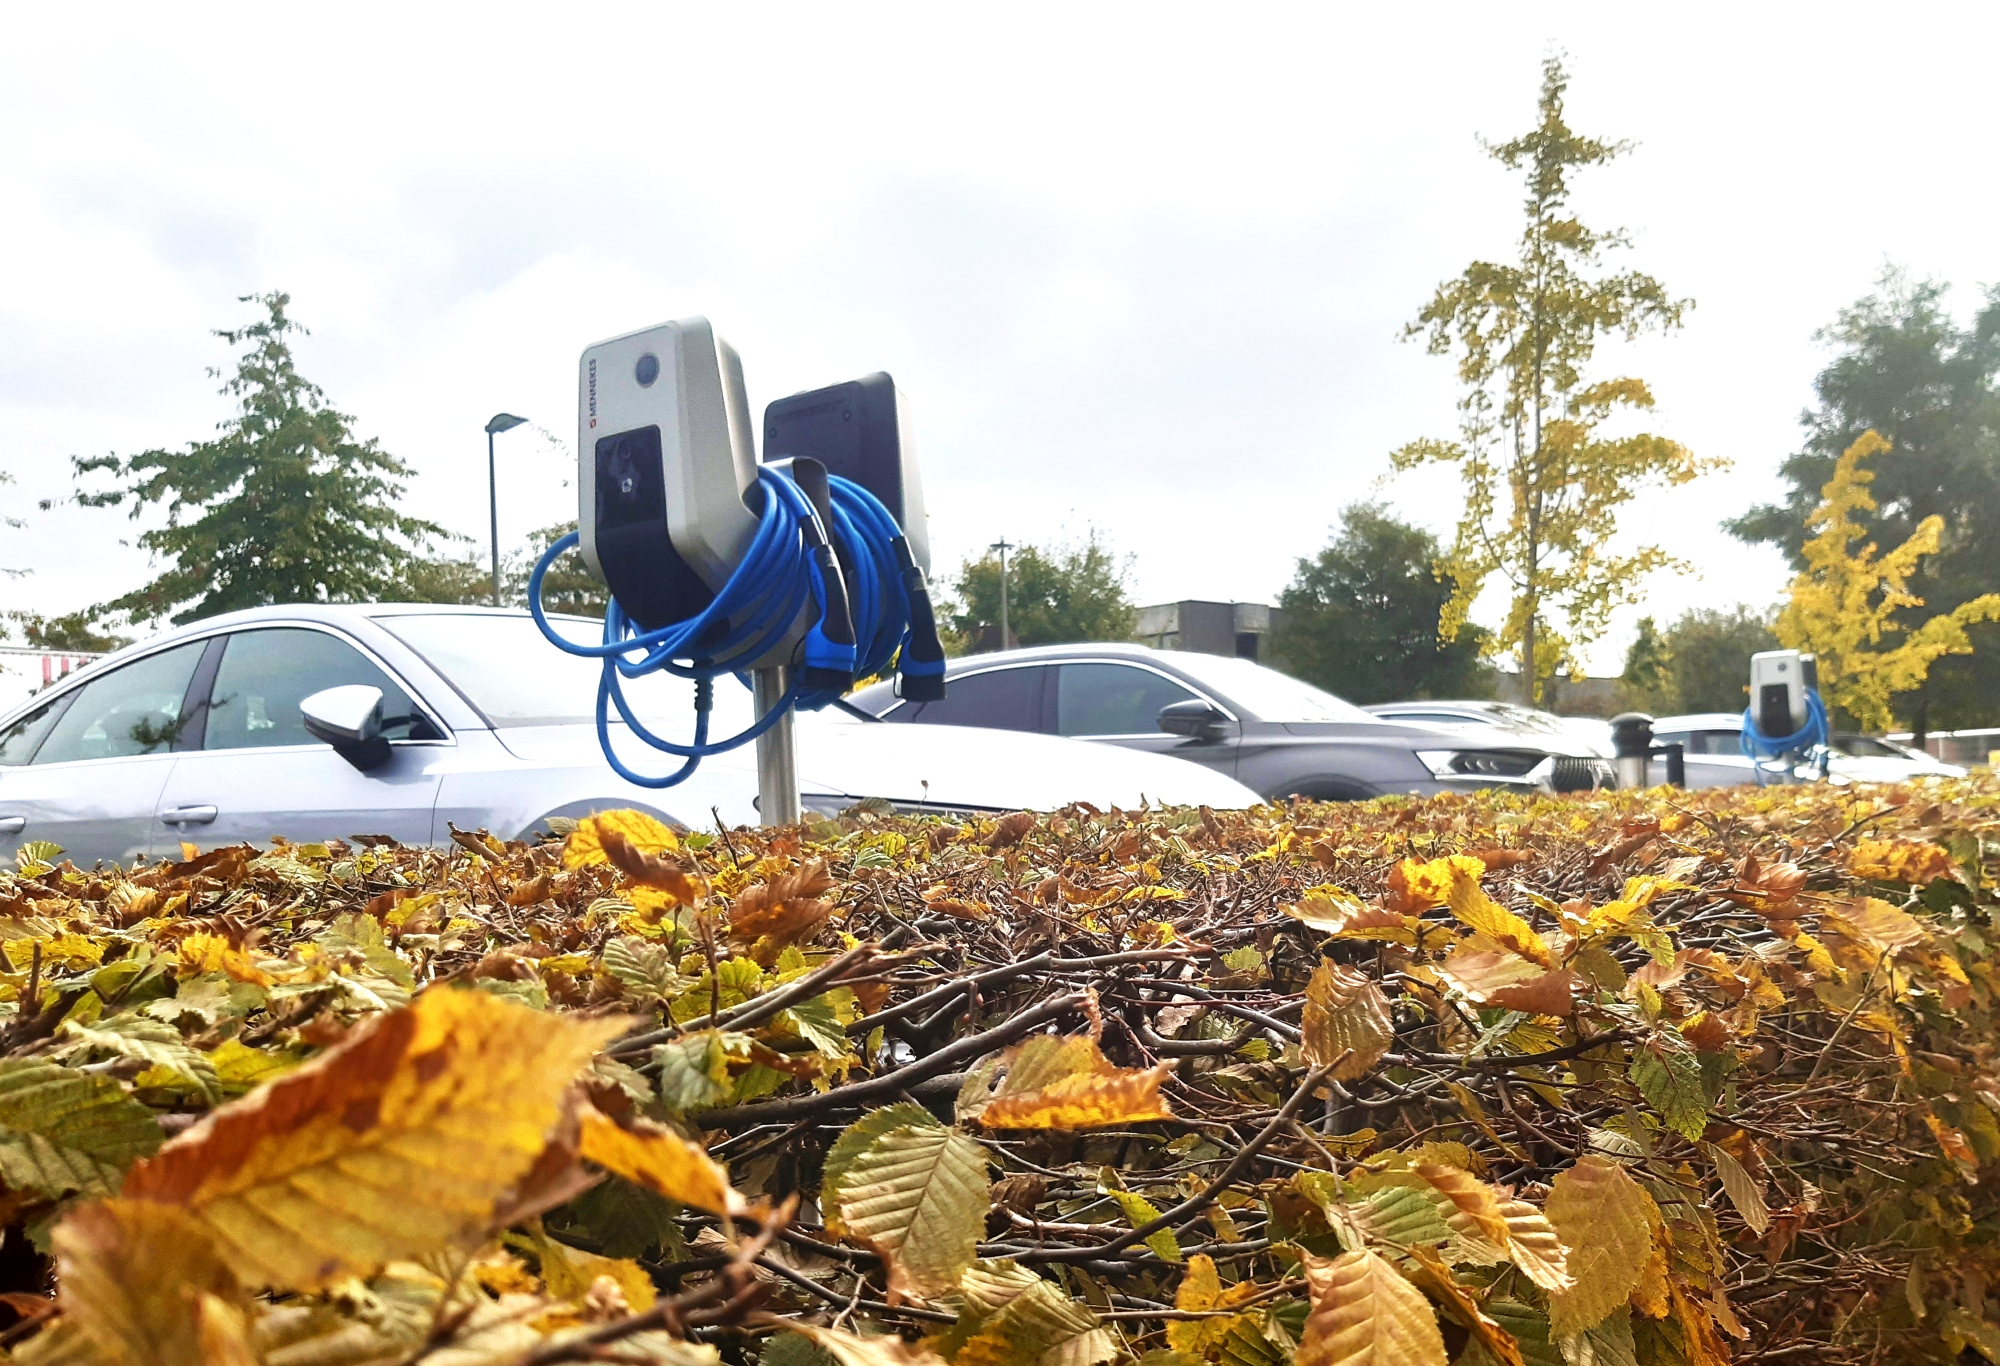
{"left": 376, "top": 612, "right": 852, "bottom": 740}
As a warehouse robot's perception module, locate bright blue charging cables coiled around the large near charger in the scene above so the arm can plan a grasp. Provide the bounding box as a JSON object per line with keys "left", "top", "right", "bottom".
{"left": 528, "top": 468, "right": 944, "bottom": 788}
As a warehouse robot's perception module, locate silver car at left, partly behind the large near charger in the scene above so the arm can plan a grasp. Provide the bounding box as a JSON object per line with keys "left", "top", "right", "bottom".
{"left": 0, "top": 606, "right": 1258, "bottom": 864}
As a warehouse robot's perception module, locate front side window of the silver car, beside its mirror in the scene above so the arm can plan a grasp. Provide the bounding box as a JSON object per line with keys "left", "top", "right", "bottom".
{"left": 202, "top": 626, "right": 438, "bottom": 750}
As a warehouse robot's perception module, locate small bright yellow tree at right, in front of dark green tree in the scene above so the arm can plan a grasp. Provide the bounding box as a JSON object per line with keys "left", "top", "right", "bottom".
{"left": 1772, "top": 430, "right": 2000, "bottom": 730}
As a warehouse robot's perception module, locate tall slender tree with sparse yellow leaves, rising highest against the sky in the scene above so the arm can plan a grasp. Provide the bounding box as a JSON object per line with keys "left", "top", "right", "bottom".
{"left": 1394, "top": 58, "right": 1722, "bottom": 698}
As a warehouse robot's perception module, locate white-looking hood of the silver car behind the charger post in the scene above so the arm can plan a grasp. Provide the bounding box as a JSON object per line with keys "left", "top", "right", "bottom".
{"left": 496, "top": 716, "right": 1262, "bottom": 810}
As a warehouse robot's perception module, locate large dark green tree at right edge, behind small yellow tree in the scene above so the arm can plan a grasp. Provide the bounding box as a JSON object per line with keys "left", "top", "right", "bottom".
{"left": 1728, "top": 268, "right": 2000, "bottom": 734}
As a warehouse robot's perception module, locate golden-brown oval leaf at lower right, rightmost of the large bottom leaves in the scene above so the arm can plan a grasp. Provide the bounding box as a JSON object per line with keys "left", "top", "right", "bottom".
{"left": 1548, "top": 1154, "right": 1660, "bottom": 1338}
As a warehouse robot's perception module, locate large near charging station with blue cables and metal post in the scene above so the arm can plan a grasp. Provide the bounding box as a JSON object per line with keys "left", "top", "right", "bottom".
{"left": 528, "top": 318, "right": 944, "bottom": 824}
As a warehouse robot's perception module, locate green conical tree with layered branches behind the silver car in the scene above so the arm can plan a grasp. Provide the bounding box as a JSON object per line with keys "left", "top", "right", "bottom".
{"left": 74, "top": 294, "right": 446, "bottom": 622}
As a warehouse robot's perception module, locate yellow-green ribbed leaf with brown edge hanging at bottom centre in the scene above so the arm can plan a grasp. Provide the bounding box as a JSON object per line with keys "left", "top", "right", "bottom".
{"left": 838, "top": 1116, "right": 992, "bottom": 1298}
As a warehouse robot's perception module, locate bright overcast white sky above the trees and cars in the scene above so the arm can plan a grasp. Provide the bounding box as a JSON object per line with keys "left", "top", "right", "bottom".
{"left": 0, "top": 2, "right": 2000, "bottom": 672}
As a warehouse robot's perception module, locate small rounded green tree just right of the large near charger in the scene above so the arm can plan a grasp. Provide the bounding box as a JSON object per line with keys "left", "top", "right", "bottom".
{"left": 946, "top": 530, "right": 1138, "bottom": 652}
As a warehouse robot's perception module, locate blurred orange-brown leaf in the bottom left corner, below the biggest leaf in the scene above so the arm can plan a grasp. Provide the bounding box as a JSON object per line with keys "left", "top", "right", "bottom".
{"left": 50, "top": 1200, "right": 252, "bottom": 1366}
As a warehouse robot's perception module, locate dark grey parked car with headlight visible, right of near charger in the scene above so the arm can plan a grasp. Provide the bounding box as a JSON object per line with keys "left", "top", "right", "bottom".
{"left": 852, "top": 644, "right": 1588, "bottom": 800}
